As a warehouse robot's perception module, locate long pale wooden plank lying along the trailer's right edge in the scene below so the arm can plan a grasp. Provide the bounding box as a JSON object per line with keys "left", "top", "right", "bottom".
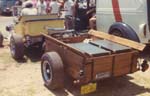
{"left": 88, "top": 30, "right": 146, "bottom": 51}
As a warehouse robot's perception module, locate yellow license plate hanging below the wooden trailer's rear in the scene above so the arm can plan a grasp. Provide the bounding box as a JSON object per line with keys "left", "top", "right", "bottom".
{"left": 81, "top": 83, "right": 96, "bottom": 95}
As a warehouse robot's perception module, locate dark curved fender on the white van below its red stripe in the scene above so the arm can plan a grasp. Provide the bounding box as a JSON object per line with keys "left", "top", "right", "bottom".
{"left": 108, "top": 22, "right": 140, "bottom": 42}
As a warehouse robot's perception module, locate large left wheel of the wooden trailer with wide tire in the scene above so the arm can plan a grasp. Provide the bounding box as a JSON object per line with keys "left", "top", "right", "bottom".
{"left": 41, "top": 52, "right": 64, "bottom": 89}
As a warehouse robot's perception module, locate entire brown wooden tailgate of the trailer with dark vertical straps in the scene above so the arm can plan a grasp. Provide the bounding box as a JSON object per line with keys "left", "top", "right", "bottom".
{"left": 93, "top": 51, "right": 138, "bottom": 80}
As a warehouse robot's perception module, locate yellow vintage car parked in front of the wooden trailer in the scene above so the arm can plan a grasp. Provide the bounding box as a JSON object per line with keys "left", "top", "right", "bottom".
{"left": 6, "top": 15, "right": 64, "bottom": 59}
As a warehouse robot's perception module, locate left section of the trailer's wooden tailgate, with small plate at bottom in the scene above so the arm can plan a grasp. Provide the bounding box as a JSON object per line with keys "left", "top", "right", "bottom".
{"left": 93, "top": 56, "right": 113, "bottom": 80}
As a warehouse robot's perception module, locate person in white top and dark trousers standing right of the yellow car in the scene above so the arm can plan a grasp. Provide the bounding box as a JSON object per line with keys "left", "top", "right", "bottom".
{"left": 64, "top": 0, "right": 74, "bottom": 29}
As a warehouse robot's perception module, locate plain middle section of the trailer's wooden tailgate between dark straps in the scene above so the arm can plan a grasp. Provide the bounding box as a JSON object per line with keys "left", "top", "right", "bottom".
{"left": 113, "top": 53, "right": 132, "bottom": 76}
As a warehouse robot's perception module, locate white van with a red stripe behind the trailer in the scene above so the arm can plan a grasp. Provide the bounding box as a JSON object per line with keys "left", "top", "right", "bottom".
{"left": 96, "top": 0, "right": 150, "bottom": 43}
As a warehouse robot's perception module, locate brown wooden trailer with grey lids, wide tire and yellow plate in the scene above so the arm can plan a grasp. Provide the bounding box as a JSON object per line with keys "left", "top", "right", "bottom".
{"left": 41, "top": 30, "right": 148, "bottom": 94}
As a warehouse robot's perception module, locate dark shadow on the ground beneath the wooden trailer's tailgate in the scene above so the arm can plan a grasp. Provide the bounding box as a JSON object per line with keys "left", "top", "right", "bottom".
{"left": 46, "top": 76, "right": 150, "bottom": 96}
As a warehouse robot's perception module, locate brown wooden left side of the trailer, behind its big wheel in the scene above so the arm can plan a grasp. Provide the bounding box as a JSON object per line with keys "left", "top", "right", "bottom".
{"left": 46, "top": 40, "right": 84, "bottom": 79}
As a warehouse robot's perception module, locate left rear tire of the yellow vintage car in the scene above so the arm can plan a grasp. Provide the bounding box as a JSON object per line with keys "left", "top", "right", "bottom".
{"left": 10, "top": 34, "right": 24, "bottom": 59}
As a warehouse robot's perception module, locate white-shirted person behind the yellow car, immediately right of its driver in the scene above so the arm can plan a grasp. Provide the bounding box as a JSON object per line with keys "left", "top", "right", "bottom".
{"left": 36, "top": 0, "right": 46, "bottom": 15}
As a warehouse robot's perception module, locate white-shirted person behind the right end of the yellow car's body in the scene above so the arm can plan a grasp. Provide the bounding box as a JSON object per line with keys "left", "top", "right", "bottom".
{"left": 50, "top": 0, "right": 60, "bottom": 15}
